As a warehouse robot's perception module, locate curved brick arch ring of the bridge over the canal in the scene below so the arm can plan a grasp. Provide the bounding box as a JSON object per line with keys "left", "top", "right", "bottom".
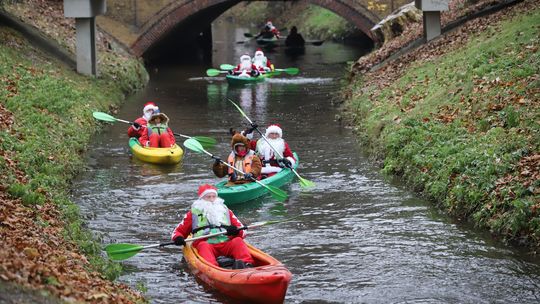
{"left": 131, "top": 0, "right": 380, "bottom": 56}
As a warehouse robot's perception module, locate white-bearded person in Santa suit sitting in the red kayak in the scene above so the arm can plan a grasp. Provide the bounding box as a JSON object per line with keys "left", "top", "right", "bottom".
{"left": 171, "top": 184, "right": 254, "bottom": 269}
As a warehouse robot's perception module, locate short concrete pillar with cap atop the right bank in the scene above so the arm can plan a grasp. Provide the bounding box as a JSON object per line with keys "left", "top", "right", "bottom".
{"left": 414, "top": 0, "right": 449, "bottom": 41}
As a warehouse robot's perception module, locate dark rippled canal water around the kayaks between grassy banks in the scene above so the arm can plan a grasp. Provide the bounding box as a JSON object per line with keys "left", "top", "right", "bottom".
{"left": 73, "top": 22, "right": 540, "bottom": 303}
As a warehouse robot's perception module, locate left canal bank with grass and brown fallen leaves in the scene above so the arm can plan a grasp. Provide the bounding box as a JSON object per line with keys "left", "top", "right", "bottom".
{"left": 0, "top": 20, "right": 147, "bottom": 303}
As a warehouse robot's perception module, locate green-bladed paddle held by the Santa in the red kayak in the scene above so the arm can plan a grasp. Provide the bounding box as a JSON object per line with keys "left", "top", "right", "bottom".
{"left": 104, "top": 215, "right": 302, "bottom": 261}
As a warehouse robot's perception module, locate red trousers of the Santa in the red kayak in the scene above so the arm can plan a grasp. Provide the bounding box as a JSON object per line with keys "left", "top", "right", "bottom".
{"left": 195, "top": 237, "right": 255, "bottom": 266}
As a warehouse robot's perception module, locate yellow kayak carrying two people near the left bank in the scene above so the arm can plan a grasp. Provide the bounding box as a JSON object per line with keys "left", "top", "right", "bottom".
{"left": 129, "top": 137, "right": 184, "bottom": 165}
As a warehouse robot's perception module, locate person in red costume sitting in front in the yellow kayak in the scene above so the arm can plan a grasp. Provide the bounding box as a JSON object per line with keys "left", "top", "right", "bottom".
{"left": 139, "top": 113, "right": 176, "bottom": 148}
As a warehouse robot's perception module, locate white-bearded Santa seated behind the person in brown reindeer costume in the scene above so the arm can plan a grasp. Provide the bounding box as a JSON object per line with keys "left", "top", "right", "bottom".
{"left": 242, "top": 124, "right": 296, "bottom": 177}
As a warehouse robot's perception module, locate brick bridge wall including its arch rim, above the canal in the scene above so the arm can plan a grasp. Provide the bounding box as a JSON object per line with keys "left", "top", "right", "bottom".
{"left": 98, "top": 0, "right": 401, "bottom": 55}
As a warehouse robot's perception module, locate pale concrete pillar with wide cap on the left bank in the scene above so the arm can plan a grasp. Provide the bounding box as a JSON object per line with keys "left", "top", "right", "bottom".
{"left": 64, "top": 0, "right": 106, "bottom": 76}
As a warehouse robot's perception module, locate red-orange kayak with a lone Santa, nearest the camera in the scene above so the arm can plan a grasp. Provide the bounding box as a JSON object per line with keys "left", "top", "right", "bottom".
{"left": 184, "top": 243, "right": 292, "bottom": 303}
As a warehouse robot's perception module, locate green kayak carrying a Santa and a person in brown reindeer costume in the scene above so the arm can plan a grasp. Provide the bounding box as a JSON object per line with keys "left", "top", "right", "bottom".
{"left": 216, "top": 153, "right": 299, "bottom": 206}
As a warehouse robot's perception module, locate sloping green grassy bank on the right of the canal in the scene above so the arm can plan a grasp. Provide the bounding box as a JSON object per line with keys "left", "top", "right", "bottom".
{"left": 347, "top": 1, "right": 540, "bottom": 246}
